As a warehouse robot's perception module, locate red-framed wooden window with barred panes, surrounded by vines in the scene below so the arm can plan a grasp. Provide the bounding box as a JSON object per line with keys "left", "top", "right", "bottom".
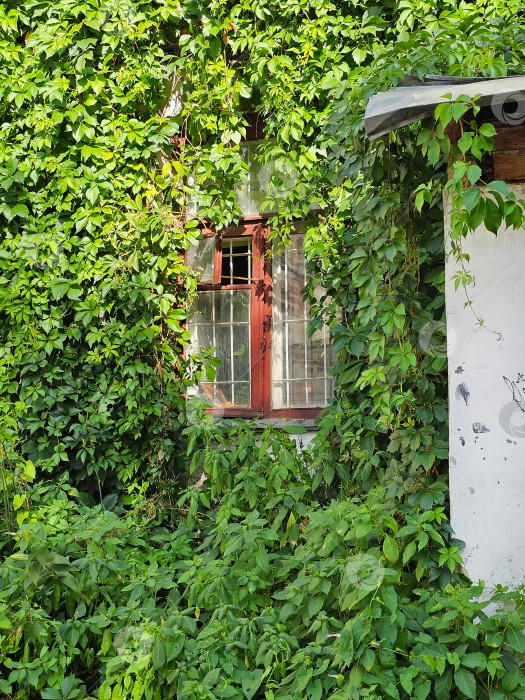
{"left": 188, "top": 218, "right": 333, "bottom": 418}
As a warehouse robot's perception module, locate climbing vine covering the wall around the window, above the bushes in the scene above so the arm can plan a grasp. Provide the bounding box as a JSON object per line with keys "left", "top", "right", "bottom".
{"left": 0, "top": 2, "right": 446, "bottom": 493}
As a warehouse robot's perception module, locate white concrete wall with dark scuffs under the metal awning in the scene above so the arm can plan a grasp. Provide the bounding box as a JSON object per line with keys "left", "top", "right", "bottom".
{"left": 445, "top": 189, "right": 525, "bottom": 588}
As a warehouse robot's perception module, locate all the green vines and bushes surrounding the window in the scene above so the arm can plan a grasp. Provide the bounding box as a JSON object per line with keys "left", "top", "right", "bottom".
{"left": 0, "top": 0, "right": 525, "bottom": 700}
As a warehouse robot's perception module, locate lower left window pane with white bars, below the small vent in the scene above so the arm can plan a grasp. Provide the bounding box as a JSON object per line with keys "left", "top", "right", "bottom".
{"left": 188, "top": 289, "right": 251, "bottom": 408}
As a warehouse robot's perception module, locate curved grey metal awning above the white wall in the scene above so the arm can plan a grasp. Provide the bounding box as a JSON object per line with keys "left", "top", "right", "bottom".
{"left": 365, "top": 75, "right": 525, "bottom": 140}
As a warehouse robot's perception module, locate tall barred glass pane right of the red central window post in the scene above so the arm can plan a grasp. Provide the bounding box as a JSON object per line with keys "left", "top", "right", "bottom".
{"left": 272, "top": 234, "right": 333, "bottom": 409}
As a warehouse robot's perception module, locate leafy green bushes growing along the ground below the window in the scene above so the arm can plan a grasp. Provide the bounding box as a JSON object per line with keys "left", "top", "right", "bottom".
{"left": 0, "top": 424, "right": 525, "bottom": 700}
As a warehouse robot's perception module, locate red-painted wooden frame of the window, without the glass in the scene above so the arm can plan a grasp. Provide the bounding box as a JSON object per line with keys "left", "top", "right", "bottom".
{"left": 197, "top": 216, "right": 323, "bottom": 419}
